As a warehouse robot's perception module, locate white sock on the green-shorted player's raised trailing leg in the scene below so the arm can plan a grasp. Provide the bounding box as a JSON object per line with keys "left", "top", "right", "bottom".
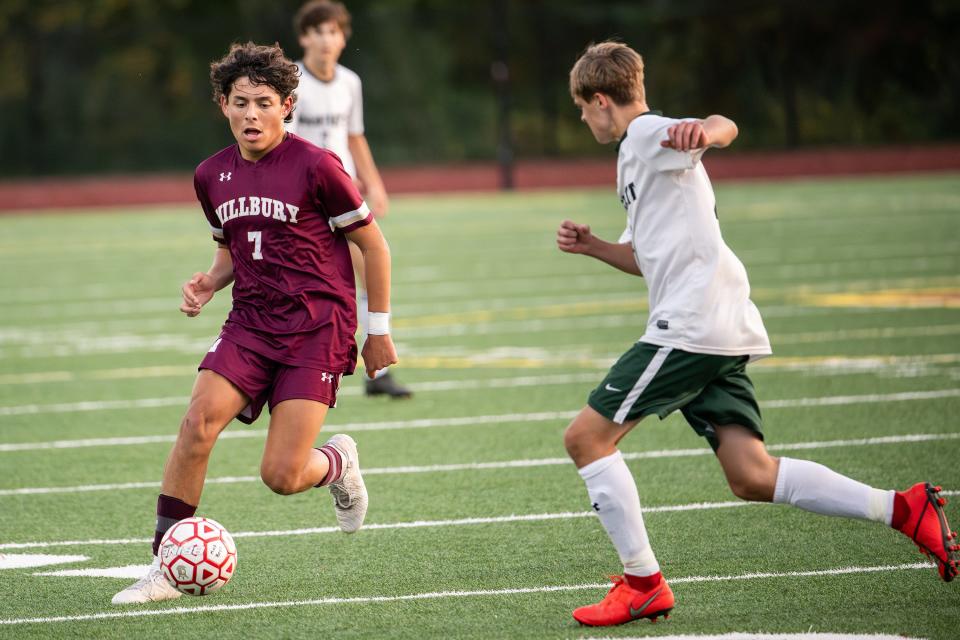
{"left": 773, "top": 458, "right": 894, "bottom": 526}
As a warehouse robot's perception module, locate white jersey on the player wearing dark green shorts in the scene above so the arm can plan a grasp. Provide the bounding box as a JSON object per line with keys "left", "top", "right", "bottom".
{"left": 617, "top": 113, "right": 771, "bottom": 357}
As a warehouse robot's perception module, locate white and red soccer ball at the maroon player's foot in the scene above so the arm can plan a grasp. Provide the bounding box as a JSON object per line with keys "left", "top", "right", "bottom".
{"left": 159, "top": 517, "right": 237, "bottom": 596}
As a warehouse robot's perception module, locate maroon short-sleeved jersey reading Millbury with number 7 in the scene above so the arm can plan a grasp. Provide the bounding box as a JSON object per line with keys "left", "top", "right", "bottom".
{"left": 194, "top": 133, "right": 373, "bottom": 373}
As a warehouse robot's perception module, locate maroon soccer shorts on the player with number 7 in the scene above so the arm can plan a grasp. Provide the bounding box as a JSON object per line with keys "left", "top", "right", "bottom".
{"left": 199, "top": 338, "right": 341, "bottom": 424}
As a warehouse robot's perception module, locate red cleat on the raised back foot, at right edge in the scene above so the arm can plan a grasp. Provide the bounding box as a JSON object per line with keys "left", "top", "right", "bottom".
{"left": 897, "top": 482, "right": 960, "bottom": 582}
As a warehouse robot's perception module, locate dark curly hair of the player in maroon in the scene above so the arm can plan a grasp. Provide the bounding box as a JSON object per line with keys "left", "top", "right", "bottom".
{"left": 210, "top": 42, "right": 300, "bottom": 122}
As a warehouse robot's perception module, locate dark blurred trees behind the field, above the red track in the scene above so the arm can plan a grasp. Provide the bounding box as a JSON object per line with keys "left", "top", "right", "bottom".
{"left": 0, "top": 0, "right": 960, "bottom": 177}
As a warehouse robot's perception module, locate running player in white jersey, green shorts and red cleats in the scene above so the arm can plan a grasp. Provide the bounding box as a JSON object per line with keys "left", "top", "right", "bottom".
{"left": 557, "top": 42, "right": 960, "bottom": 626}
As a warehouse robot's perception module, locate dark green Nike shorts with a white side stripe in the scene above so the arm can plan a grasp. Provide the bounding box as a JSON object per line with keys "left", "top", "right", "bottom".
{"left": 587, "top": 342, "right": 763, "bottom": 450}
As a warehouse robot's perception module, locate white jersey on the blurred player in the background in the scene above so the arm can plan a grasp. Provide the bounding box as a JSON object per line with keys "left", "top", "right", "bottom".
{"left": 287, "top": 60, "right": 363, "bottom": 178}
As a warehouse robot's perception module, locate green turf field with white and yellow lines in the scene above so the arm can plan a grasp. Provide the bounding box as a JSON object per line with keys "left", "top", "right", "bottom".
{"left": 0, "top": 175, "right": 960, "bottom": 640}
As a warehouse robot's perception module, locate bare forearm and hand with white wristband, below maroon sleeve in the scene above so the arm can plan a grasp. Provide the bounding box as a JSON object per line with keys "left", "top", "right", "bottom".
{"left": 347, "top": 221, "right": 397, "bottom": 378}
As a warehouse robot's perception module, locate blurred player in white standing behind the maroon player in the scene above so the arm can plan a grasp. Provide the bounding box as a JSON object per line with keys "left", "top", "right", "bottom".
{"left": 287, "top": 0, "right": 412, "bottom": 398}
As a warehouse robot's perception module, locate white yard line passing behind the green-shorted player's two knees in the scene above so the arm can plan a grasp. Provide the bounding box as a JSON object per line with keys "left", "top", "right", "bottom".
{"left": 0, "top": 433, "right": 960, "bottom": 497}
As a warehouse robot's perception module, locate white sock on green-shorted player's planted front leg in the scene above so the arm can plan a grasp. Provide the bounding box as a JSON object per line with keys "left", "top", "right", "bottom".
{"left": 579, "top": 451, "right": 660, "bottom": 576}
